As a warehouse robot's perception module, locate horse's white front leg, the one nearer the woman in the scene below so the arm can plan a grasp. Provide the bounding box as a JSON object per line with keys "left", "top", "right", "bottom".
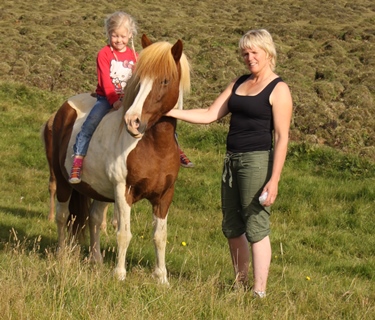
{"left": 153, "top": 215, "right": 169, "bottom": 285}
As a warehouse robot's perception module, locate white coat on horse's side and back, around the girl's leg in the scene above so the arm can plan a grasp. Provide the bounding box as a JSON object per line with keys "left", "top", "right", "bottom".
{"left": 65, "top": 93, "right": 139, "bottom": 199}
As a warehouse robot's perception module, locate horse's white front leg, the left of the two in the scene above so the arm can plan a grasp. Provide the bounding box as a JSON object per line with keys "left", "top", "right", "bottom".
{"left": 114, "top": 184, "right": 132, "bottom": 280}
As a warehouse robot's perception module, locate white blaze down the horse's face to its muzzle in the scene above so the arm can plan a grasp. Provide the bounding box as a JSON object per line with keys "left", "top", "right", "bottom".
{"left": 125, "top": 78, "right": 153, "bottom": 129}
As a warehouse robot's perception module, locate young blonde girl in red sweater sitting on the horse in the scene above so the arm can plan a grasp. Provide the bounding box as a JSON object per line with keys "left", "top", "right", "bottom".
{"left": 69, "top": 12, "right": 193, "bottom": 184}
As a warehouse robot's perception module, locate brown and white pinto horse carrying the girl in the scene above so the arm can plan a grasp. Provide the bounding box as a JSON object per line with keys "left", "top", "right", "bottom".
{"left": 44, "top": 35, "right": 190, "bottom": 284}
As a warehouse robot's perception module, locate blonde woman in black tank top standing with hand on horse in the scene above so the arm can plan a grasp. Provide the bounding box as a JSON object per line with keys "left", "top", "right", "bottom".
{"left": 167, "top": 29, "right": 293, "bottom": 298}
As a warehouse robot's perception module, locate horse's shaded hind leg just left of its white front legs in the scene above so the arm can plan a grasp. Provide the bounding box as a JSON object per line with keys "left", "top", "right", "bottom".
{"left": 89, "top": 201, "right": 109, "bottom": 263}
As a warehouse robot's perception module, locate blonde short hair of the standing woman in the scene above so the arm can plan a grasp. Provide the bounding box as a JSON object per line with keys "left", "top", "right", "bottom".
{"left": 238, "top": 29, "right": 277, "bottom": 70}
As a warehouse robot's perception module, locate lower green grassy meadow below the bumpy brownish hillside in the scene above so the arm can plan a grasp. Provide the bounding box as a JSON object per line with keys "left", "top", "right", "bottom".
{"left": 0, "top": 83, "right": 375, "bottom": 319}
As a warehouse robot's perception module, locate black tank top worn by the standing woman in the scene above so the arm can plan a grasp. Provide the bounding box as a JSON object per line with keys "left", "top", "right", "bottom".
{"left": 227, "top": 75, "right": 283, "bottom": 153}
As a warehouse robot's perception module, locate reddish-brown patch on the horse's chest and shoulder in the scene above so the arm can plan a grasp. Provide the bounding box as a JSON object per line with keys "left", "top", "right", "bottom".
{"left": 125, "top": 117, "right": 180, "bottom": 219}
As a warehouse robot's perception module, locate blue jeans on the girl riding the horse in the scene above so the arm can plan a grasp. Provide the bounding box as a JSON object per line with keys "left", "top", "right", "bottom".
{"left": 73, "top": 95, "right": 112, "bottom": 156}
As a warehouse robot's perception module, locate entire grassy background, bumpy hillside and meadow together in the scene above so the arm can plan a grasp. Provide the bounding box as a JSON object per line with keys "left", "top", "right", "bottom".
{"left": 0, "top": 0, "right": 375, "bottom": 320}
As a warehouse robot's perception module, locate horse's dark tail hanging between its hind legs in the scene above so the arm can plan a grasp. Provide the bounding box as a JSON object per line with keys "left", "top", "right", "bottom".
{"left": 68, "top": 189, "right": 91, "bottom": 241}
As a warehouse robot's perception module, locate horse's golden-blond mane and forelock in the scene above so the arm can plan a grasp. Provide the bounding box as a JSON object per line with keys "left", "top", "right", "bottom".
{"left": 122, "top": 41, "right": 190, "bottom": 119}
